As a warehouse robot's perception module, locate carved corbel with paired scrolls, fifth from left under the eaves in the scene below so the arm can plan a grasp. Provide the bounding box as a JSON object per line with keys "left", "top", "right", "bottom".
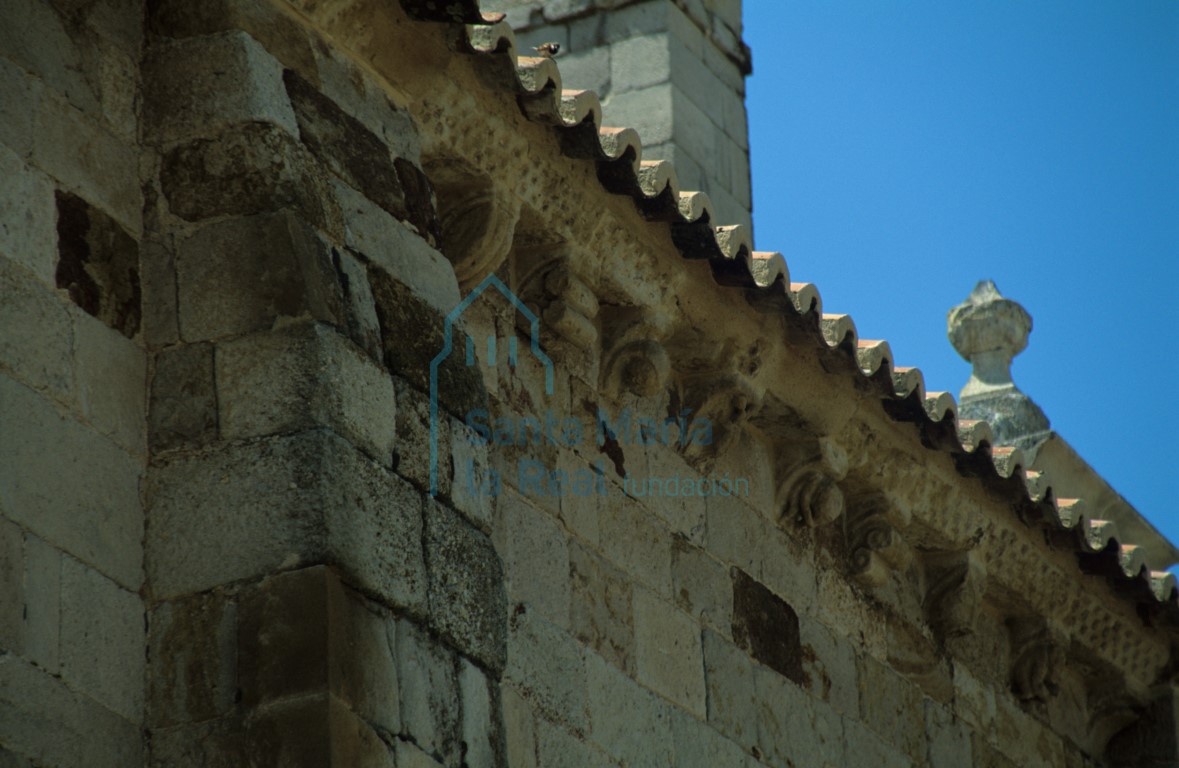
{"left": 777, "top": 438, "right": 848, "bottom": 527}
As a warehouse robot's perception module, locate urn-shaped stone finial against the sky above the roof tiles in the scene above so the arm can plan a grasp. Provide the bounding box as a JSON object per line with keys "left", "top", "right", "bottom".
{"left": 946, "top": 280, "right": 1048, "bottom": 447}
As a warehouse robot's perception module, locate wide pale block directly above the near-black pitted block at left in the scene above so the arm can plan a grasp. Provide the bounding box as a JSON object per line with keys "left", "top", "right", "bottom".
{"left": 33, "top": 91, "right": 144, "bottom": 238}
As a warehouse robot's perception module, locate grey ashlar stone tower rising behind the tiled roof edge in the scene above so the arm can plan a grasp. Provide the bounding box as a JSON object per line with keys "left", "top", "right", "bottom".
{"left": 483, "top": 0, "right": 752, "bottom": 227}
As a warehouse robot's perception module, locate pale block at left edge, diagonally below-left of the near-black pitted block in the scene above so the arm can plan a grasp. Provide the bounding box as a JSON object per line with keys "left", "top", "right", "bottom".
{"left": 0, "top": 257, "right": 73, "bottom": 402}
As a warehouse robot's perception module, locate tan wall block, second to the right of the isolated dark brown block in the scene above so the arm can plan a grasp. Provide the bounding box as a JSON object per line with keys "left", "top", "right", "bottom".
{"left": 856, "top": 655, "right": 926, "bottom": 760}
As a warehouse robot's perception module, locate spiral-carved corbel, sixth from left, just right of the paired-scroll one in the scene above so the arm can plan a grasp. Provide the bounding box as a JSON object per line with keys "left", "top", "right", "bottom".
{"left": 844, "top": 495, "right": 913, "bottom": 588}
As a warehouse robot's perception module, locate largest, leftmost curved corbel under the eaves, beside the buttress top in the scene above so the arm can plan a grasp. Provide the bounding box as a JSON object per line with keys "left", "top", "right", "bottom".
{"left": 426, "top": 160, "right": 520, "bottom": 291}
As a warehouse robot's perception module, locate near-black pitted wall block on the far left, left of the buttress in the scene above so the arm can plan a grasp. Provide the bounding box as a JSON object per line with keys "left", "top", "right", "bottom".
{"left": 54, "top": 192, "right": 141, "bottom": 339}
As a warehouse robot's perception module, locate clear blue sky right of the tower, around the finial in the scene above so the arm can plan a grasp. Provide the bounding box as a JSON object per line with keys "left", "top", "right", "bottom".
{"left": 744, "top": 0, "right": 1179, "bottom": 543}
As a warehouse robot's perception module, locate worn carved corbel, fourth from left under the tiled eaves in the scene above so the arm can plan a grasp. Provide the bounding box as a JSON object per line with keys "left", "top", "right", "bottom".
{"left": 679, "top": 373, "right": 760, "bottom": 465}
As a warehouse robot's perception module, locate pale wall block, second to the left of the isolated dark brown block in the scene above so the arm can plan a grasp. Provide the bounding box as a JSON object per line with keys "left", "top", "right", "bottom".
{"left": 600, "top": 495, "right": 672, "bottom": 596}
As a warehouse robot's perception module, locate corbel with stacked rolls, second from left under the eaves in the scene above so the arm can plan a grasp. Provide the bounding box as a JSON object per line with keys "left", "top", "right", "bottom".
{"left": 520, "top": 250, "right": 598, "bottom": 349}
